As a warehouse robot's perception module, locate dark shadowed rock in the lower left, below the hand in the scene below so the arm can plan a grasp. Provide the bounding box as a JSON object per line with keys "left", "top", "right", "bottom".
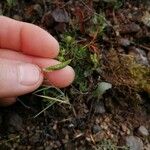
{"left": 4, "top": 112, "right": 23, "bottom": 133}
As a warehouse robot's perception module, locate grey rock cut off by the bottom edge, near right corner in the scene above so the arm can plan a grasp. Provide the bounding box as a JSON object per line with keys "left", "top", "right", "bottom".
{"left": 126, "top": 136, "right": 144, "bottom": 150}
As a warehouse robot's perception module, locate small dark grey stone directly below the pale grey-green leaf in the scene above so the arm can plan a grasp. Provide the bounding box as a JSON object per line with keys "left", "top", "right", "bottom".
{"left": 93, "top": 101, "right": 106, "bottom": 115}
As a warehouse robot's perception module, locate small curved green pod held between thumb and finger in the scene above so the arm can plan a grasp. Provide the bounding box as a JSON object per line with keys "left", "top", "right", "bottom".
{"left": 43, "top": 59, "right": 71, "bottom": 72}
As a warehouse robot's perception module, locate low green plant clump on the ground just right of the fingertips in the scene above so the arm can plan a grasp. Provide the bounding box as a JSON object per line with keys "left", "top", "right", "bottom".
{"left": 58, "top": 34, "right": 100, "bottom": 92}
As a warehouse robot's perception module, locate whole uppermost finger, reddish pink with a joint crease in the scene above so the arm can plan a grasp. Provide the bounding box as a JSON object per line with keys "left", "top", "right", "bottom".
{"left": 0, "top": 16, "right": 59, "bottom": 58}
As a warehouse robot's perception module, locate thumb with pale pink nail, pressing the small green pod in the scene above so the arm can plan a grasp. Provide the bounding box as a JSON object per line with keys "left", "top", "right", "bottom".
{"left": 0, "top": 58, "right": 43, "bottom": 98}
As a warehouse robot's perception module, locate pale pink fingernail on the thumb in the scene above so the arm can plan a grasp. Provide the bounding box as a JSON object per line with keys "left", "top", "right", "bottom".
{"left": 18, "top": 64, "right": 40, "bottom": 86}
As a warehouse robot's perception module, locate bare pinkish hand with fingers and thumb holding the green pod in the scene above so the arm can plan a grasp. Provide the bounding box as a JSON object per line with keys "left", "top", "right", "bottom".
{"left": 0, "top": 16, "right": 75, "bottom": 106}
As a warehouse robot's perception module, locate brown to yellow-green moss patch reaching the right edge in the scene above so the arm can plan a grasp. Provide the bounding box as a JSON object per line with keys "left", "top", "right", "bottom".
{"left": 103, "top": 50, "right": 150, "bottom": 93}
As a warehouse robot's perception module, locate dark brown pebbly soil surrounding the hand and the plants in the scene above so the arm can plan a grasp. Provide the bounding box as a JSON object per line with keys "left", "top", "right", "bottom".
{"left": 0, "top": 0, "right": 150, "bottom": 150}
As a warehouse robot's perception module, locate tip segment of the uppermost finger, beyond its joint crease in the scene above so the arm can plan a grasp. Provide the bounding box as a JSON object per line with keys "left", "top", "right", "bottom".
{"left": 21, "top": 23, "right": 59, "bottom": 58}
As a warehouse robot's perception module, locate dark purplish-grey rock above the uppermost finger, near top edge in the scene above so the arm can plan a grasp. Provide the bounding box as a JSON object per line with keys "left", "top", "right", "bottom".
{"left": 52, "top": 8, "right": 70, "bottom": 23}
